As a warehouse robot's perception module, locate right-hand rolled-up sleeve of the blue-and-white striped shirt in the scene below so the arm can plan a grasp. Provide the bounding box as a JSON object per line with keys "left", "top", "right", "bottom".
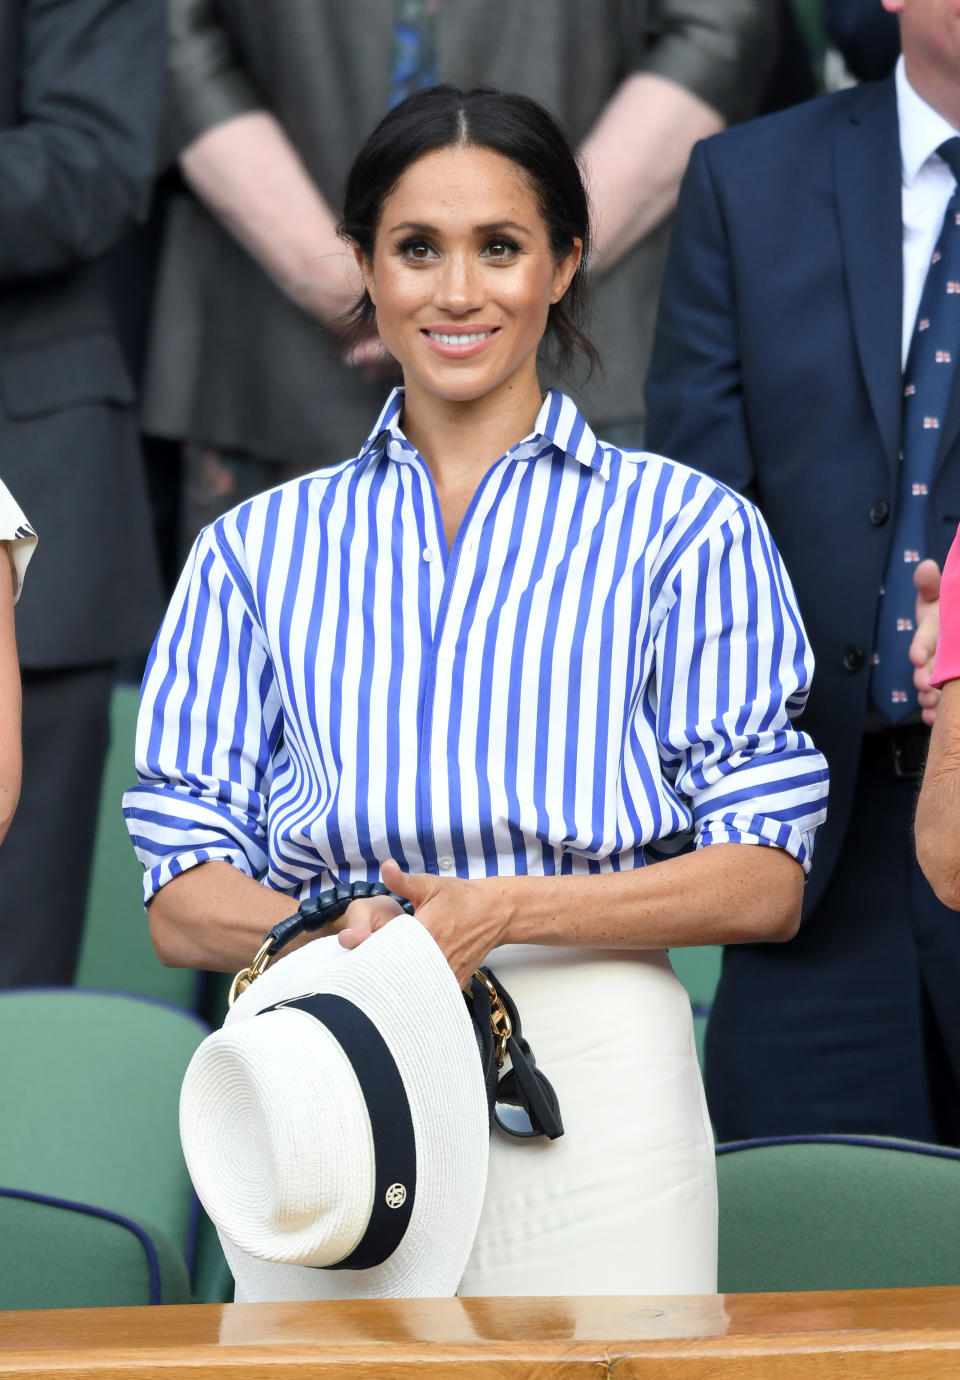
{"left": 657, "top": 498, "right": 829, "bottom": 871}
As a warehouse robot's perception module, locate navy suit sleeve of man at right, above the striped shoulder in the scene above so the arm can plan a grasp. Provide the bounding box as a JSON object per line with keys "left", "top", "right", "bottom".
{"left": 646, "top": 144, "right": 756, "bottom": 498}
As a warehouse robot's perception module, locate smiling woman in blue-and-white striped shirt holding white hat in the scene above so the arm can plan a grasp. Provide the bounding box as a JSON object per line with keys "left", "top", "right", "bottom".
{"left": 126, "top": 87, "right": 826, "bottom": 1294}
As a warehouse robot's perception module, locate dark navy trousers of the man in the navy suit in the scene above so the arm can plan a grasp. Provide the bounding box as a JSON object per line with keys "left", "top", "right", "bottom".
{"left": 706, "top": 734, "right": 960, "bottom": 1145}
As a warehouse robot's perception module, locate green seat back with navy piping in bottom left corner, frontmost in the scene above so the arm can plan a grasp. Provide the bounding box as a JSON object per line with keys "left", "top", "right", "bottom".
{"left": 0, "top": 1188, "right": 190, "bottom": 1308}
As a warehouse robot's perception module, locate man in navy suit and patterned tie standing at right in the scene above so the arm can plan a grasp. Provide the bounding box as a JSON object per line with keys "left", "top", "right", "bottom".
{"left": 647, "top": 0, "right": 960, "bottom": 1144}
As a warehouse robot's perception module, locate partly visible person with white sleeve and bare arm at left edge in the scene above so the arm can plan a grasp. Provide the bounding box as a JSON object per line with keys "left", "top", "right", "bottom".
{"left": 0, "top": 482, "right": 37, "bottom": 839}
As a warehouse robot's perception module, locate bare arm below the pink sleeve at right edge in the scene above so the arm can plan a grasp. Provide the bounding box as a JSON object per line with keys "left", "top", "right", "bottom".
{"left": 914, "top": 680, "right": 960, "bottom": 911}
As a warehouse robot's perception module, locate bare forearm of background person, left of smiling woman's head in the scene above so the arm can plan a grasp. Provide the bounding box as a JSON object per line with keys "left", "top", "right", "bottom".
{"left": 181, "top": 110, "right": 360, "bottom": 323}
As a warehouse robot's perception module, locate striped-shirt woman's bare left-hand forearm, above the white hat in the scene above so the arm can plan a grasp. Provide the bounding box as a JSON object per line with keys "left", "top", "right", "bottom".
{"left": 148, "top": 863, "right": 322, "bottom": 973}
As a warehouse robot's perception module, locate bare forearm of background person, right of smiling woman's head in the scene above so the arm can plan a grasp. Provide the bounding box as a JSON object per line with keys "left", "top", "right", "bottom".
{"left": 581, "top": 72, "right": 724, "bottom": 270}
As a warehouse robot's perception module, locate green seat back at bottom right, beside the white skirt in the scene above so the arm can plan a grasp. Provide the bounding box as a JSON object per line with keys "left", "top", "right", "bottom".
{"left": 717, "top": 1137, "right": 960, "bottom": 1293}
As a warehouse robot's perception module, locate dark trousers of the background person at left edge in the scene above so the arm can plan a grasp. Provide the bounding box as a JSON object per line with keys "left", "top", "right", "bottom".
{"left": 0, "top": 667, "right": 113, "bottom": 987}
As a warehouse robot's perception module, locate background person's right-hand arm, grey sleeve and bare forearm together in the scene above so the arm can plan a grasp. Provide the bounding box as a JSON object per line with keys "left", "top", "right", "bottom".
{"left": 581, "top": 0, "right": 777, "bottom": 272}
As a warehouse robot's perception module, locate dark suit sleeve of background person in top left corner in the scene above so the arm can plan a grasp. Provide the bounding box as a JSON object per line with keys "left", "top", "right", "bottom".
{"left": 0, "top": 0, "right": 164, "bottom": 282}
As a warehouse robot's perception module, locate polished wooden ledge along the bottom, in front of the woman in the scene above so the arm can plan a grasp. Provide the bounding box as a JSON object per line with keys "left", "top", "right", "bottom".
{"left": 0, "top": 1288, "right": 960, "bottom": 1380}
